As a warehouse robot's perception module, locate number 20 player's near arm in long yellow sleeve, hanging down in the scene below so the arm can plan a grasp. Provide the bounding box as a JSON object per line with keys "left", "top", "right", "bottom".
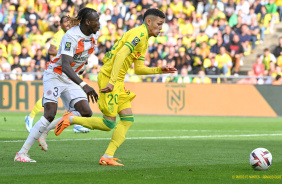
{"left": 101, "top": 45, "right": 131, "bottom": 93}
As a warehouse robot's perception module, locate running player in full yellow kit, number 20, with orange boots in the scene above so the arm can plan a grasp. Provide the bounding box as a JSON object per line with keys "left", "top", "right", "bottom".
{"left": 55, "top": 9, "right": 176, "bottom": 166}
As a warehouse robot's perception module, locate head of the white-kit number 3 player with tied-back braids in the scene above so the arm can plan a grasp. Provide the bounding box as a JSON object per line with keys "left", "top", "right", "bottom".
{"left": 69, "top": 8, "right": 100, "bottom": 34}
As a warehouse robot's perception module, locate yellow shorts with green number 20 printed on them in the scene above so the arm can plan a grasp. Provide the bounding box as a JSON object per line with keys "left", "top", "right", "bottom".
{"left": 98, "top": 72, "right": 136, "bottom": 117}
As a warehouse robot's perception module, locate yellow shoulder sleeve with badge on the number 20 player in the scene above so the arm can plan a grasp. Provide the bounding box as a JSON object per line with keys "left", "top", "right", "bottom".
{"left": 124, "top": 31, "right": 146, "bottom": 53}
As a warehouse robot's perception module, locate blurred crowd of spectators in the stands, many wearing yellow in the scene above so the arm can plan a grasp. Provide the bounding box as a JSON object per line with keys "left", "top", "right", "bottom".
{"left": 0, "top": 0, "right": 282, "bottom": 83}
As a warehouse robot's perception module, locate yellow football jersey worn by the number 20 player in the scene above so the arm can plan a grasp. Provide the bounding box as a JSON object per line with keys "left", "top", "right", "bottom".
{"left": 101, "top": 24, "right": 149, "bottom": 81}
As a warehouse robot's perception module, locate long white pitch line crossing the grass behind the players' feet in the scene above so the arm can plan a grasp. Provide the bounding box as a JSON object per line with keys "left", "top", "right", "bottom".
{"left": 0, "top": 134, "right": 282, "bottom": 143}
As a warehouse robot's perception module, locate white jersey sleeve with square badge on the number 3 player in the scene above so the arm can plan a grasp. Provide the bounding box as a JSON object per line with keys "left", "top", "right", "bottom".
{"left": 60, "top": 34, "right": 78, "bottom": 57}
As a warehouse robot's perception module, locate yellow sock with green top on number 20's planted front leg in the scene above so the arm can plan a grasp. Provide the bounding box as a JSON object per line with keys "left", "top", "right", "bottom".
{"left": 105, "top": 115, "right": 134, "bottom": 156}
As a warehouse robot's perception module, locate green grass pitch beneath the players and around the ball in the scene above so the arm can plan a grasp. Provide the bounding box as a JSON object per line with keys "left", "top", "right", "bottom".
{"left": 0, "top": 112, "right": 282, "bottom": 184}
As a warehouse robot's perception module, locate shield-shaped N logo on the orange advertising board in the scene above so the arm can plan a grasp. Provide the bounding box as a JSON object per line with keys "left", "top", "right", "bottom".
{"left": 167, "top": 85, "right": 186, "bottom": 114}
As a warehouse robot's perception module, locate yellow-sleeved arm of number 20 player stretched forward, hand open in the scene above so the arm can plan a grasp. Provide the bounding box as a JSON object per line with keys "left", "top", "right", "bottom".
{"left": 134, "top": 60, "right": 177, "bottom": 75}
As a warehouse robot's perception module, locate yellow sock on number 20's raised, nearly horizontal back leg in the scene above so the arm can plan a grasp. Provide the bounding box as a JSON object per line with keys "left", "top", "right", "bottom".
{"left": 72, "top": 116, "right": 115, "bottom": 131}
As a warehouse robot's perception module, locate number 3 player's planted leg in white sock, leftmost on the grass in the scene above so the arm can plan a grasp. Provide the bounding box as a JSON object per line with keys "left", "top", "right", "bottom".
{"left": 14, "top": 102, "right": 57, "bottom": 162}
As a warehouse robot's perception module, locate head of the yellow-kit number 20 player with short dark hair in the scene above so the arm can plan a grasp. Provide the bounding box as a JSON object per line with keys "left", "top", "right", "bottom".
{"left": 143, "top": 8, "right": 165, "bottom": 37}
